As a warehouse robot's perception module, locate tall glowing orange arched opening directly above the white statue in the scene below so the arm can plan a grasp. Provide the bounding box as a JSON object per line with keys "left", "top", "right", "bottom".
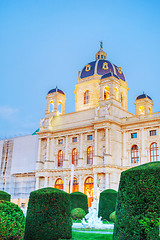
{"left": 84, "top": 177, "right": 94, "bottom": 207}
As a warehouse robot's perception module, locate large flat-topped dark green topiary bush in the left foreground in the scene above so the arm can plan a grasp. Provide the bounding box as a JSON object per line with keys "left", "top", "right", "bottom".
{"left": 24, "top": 187, "right": 72, "bottom": 240}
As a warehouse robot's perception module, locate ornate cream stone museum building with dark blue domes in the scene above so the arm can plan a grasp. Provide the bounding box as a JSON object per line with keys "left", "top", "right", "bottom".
{"left": 0, "top": 42, "right": 160, "bottom": 206}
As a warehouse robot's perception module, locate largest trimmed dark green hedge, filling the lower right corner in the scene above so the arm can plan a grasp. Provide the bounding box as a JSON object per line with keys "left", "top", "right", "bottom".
{"left": 113, "top": 162, "right": 160, "bottom": 240}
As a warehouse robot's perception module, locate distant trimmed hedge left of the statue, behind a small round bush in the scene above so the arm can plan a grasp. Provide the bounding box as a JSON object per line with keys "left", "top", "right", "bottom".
{"left": 70, "top": 192, "right": 88, "bottom": 214}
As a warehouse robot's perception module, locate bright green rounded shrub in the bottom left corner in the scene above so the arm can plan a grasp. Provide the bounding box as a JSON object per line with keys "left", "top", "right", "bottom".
{"left": 0, "top": 200, "right": 25, "bottom": 240}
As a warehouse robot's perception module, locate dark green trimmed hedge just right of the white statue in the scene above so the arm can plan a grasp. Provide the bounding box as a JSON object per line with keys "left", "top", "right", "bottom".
{"left": 98, "top": 189, "right": 117, "bottom": 220}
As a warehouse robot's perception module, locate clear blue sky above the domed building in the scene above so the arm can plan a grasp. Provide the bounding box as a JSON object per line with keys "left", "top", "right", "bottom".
{"left": 0, "top": 0, "right": 160, "bottom": 139}
